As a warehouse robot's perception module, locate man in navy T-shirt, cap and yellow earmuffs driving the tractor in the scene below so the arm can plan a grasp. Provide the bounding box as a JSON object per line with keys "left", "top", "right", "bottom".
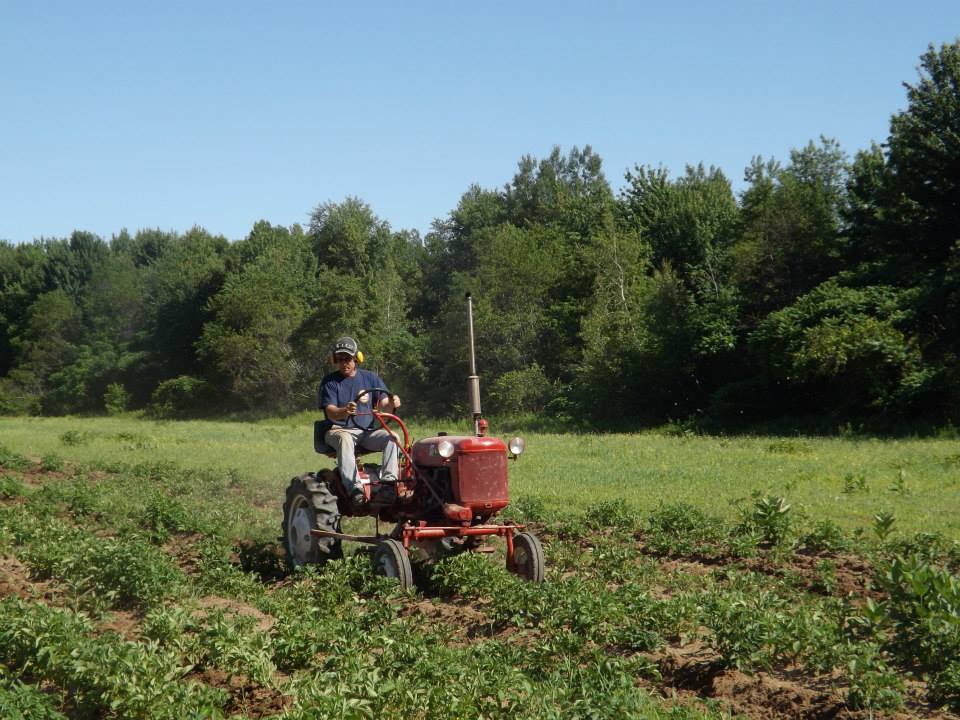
{"left": 318, "top": 337, "right": 400, "bottom": 505}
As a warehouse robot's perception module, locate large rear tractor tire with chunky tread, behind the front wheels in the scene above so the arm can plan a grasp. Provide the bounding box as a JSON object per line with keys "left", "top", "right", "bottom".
{"left": 283, "top": 473, "right": 343, "bottom": 568}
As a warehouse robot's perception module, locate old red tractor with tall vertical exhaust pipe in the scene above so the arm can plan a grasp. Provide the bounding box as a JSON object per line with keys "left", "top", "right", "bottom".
{"left": 283, "top": 295, "right": 544, "bottom": 588}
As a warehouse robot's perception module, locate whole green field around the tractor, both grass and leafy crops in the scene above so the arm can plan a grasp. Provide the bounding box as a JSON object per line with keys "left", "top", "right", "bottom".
{"left": 0, "top": 415, "right": 960, "bottom": 720}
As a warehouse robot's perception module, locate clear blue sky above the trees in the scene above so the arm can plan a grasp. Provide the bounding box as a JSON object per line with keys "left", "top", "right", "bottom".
{"left": 0, "top": 0, "right": 960, "bottom": 242}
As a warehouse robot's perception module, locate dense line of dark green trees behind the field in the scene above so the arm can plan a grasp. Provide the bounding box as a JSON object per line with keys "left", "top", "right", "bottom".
{"left": 0, "top": 40, "right": 960, "bottom": 422}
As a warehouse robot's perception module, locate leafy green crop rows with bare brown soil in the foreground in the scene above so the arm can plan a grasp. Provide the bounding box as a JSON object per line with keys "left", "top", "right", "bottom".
{"left": 0, "top": 452, "right": 960, "bottom": 718}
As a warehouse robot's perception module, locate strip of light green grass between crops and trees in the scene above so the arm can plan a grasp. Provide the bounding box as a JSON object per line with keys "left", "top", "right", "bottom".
{"left": 0, "top": 414, "right": 960, "bottom": 539}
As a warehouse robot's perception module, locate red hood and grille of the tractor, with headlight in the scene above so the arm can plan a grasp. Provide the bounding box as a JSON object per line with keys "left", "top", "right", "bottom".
{"left": 411, "top": 435, "right": 510, "bottom": 521}
